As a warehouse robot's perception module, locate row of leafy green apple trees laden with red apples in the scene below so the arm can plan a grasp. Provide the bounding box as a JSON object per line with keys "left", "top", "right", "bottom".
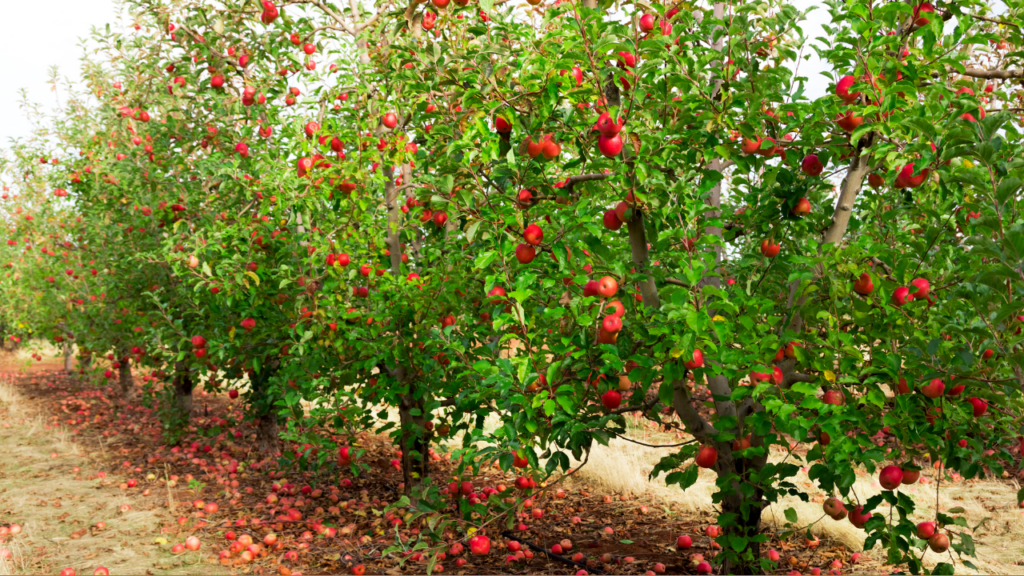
{"left": 3, "top": 0, "right": 1024, "bottom": 573}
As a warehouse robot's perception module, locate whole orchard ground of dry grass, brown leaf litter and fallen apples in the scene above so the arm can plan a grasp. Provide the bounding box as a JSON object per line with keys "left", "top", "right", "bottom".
{"left": 0, "top": 352, "right": 1024, "bottom": 575}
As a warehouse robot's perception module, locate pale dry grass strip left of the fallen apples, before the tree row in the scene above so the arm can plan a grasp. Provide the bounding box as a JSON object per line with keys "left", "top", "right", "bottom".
{"left": 0, "top": 364, "right": 227, "bottom": 575}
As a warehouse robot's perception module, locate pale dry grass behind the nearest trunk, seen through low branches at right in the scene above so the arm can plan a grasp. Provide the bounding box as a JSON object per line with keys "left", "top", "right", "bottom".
{"left": 573, "top": 416, "right": 1024, "bottom": 574}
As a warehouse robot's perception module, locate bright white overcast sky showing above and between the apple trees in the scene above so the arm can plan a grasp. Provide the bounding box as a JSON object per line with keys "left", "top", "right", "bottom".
{"left": 0, "top": 0, "right": 827, "bottom": 148}
